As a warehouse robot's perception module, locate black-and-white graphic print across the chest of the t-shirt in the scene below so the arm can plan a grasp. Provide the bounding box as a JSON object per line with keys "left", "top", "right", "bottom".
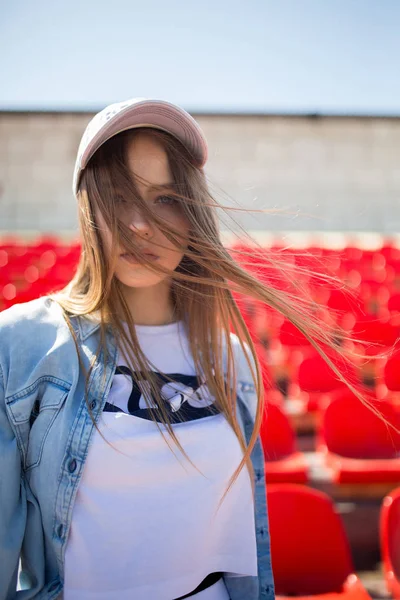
{"left": 104, "top": 365, "right": 220, "bottom": 423}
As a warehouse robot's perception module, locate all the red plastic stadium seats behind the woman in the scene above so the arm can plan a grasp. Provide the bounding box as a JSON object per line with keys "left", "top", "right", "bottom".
{"left": 0, "top": 236, "right": 400, "bottom": 600}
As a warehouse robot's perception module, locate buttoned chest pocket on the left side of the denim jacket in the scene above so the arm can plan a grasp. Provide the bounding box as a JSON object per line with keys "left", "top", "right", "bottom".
{"left": 6, "top": 376, "right": 70, "bottom": 470}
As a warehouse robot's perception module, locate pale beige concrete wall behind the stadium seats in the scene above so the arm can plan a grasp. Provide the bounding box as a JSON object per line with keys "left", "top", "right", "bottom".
{"left": 0, "top": 112, "right": 400, "bottom": 234}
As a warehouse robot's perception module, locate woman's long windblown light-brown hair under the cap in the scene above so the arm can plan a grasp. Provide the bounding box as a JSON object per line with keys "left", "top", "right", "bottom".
{"left": 51, "top": 128, "right": 384, "bottom": 510}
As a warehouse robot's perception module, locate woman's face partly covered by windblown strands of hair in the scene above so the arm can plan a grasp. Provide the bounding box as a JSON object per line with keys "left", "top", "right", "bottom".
{"left": 95, "top": 133, "right": 188, "bottom": 288}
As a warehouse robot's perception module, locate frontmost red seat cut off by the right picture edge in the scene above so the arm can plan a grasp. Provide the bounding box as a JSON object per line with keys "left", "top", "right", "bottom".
{"left": 380, "top": 488, "right": 400, "bottom": 600}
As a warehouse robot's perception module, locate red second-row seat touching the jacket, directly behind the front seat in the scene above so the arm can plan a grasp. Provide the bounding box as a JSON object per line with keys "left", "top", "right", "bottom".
{"left": 260, "top": 404, "right": 308, "bottom": 483}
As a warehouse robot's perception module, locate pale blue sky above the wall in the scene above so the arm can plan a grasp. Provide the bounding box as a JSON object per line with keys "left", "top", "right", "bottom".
{"left": 0, "top": 0, "right": 400, "bottom": 115}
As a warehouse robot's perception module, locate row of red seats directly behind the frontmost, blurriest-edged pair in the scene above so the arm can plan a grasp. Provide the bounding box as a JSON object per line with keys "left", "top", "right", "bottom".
{"left": 260, "top": 398, "right": 400, "bottom": 486}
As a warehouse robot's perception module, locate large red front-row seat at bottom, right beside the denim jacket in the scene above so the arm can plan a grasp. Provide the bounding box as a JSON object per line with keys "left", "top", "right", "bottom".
{"left": 267, "top": 484, "right": 370, "bottom": 600}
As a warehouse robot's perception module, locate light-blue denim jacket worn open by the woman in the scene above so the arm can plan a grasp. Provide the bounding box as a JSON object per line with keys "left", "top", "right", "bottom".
{"left": 0, "top": 297, "right": 275, "bottom": 600}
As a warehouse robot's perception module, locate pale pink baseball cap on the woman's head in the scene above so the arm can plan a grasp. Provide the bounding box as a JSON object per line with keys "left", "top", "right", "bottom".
{"left": 72, "top": 98, "right": 208, "bottom": 195}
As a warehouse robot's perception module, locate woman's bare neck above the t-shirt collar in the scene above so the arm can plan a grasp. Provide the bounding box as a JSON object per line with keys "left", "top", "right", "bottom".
{"left": 119, "top": 281, "right": 177, "bottom": 325}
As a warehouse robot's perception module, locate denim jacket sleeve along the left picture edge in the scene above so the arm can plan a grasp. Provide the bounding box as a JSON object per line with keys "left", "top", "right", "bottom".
{"left": 0, "top": 367, "right": 27, "bottom": 600}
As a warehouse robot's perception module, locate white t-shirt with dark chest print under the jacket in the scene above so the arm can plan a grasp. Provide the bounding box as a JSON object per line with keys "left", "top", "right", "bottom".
{"left": 64, "top": 322, "right": 257, "bottom": 600}
